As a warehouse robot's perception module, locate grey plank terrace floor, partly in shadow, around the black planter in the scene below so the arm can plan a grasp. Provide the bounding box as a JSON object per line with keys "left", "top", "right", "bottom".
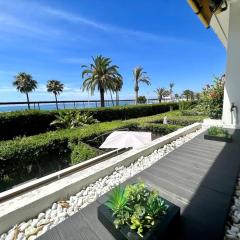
{"left": 38, "top": 131, "right": 240, "bottom": 240}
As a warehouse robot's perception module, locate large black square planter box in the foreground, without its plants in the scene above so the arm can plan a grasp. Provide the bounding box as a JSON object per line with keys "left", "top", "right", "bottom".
{"left": 98, "top": 199, "right": 180, "bottom": 240}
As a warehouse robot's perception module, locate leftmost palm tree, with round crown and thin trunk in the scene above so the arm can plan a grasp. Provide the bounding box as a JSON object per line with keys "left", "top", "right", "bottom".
{"left": 13, "top": 72, "right": 37, "bottom": 109}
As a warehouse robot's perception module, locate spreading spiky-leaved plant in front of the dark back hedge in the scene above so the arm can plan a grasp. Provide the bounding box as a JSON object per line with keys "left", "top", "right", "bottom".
{"left": 50, "top": 111, "right": 98, "bottom": 128}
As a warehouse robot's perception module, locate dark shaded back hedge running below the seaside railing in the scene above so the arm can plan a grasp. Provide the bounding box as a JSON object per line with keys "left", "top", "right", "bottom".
{"left": 0, "top": 103, "right": 178, "bottom": 140}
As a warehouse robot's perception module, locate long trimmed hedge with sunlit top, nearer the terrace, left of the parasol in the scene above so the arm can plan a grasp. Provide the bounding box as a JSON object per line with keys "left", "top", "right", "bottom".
{"left": 0, "top": 121, "right": 136, "bottom": 182}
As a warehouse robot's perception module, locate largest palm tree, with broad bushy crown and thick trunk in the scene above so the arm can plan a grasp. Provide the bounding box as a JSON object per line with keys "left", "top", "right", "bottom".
{"left": 82, "top": 55, "right": 122, "bottom": 107}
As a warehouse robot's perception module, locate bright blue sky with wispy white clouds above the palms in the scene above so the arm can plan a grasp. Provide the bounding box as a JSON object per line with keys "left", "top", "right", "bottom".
{"left": 0, "top": 0, "right": 226, "bottom": 101}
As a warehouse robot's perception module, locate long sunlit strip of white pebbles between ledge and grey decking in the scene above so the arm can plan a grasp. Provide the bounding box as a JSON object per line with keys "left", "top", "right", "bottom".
{"left": 0, "top": 128, "right": 204, "bottom": 240}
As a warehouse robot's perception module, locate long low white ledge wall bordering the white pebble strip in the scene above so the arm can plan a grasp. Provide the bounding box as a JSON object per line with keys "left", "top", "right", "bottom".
{"left": 0, "top": 123, "right": 202, "bottom": 233}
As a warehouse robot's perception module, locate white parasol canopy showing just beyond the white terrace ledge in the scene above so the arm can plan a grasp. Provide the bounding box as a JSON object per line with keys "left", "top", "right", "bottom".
{"left": 99, "top": 131, "right": 152, "bottom": 149}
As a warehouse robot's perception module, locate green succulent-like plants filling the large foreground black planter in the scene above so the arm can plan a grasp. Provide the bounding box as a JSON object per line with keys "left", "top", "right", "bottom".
{"left": 106, "top": 182, "right": 168, "bottom": 237}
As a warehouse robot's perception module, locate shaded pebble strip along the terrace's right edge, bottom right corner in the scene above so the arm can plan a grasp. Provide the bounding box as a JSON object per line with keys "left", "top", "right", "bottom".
{"left": 224, "top": 174, "right": 240, "bottom": 240}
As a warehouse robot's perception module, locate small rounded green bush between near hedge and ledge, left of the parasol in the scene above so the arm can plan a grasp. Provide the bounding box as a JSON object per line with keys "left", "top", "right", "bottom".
{"left": 71, "top": 143, "right": 100, "bottom": 165}
